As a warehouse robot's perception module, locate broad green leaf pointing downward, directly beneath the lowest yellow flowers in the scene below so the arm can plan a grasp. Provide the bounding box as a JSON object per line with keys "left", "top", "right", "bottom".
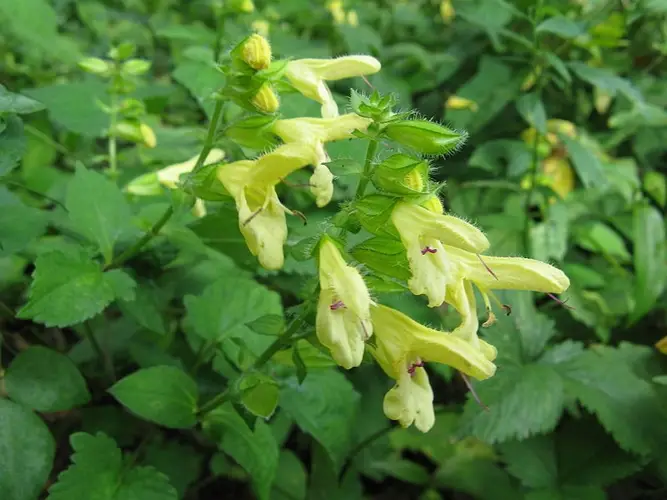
{"left": 280, "top": 370, "right": 359, "bottom": 470}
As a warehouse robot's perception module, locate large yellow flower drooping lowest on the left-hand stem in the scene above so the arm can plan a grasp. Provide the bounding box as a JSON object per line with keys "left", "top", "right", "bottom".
{"left": 217, "top": 143, "right": 316, "bottom": 270}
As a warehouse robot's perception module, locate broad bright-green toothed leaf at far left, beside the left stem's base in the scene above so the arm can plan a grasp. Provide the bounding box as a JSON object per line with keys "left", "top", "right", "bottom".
{"left": 17, "top": 252, "right": 134, "bottom": 327}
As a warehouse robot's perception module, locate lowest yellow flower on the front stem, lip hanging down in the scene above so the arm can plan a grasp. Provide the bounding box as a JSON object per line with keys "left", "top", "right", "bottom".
{"left": 371, "top": 305, "right": 496, "bottom": 432}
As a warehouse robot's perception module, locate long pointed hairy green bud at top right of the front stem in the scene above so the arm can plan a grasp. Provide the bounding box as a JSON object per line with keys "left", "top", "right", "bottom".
{"left": 384, "top": 120, "right": 468, "bottom": 155}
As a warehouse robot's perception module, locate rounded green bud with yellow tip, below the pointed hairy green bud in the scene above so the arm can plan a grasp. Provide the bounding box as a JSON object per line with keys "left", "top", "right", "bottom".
{"left": 373, "top": 154, "right": 428, "bottom": 195}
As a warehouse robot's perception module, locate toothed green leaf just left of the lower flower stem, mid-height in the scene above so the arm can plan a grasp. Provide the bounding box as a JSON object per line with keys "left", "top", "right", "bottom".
{"left": 184, "top": 277, "right": 281, "bottom": 342}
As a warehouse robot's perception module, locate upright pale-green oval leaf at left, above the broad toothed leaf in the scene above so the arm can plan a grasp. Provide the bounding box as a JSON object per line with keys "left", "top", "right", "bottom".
{"left": 65, "top": 166, "right": 132, "bottom": 264}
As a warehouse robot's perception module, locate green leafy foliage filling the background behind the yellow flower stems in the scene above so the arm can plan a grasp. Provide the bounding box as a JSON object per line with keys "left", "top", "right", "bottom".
{"left": 0, "top": 0, "right": 667, "bottom": 500}
